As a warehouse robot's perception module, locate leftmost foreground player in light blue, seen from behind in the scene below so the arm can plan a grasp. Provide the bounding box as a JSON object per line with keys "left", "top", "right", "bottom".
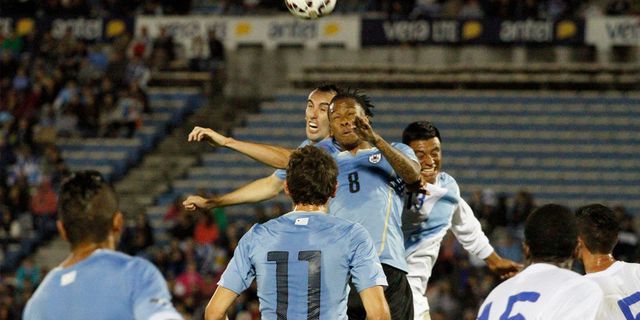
{"left": 23, "top": 171, "right": 182, "bottom": 320}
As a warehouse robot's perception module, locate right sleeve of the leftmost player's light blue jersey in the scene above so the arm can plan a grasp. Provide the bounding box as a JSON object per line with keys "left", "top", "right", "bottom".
{"left": 132, "top": 258, "right": 182, "bottom": 320}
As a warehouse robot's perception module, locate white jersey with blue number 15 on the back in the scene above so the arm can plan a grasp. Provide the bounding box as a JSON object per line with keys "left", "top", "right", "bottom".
{"left": 478, "top": 263, "right": 603, "bottom": 320}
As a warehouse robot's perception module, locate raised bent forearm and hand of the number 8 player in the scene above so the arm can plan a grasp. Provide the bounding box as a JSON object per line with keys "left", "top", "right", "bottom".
{"left": 355, "top": 117, "right": 420, "bottom": 185}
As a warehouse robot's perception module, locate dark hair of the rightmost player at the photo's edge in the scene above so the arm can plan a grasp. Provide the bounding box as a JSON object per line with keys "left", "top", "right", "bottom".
{"left": 576, "top": 203, "right": 620, "bottom": 254}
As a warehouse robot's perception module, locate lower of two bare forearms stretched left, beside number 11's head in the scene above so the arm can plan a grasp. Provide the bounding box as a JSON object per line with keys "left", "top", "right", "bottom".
{"left": 207, "top": 175, "right": 283, "bottom": 208}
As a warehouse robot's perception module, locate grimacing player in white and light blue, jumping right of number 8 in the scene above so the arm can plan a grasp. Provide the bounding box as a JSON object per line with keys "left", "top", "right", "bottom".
{"left": 402, "top": 121, "right": 522, "bottom": 320}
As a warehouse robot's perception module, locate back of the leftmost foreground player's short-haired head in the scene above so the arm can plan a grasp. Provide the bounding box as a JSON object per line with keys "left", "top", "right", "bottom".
{"left": 58, "top": 170, "right": 118, "bottom": 248}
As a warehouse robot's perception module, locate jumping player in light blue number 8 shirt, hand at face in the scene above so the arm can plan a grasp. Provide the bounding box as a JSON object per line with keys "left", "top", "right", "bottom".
{"left": 317, "top": 92, "right": 420, "bottom": 319}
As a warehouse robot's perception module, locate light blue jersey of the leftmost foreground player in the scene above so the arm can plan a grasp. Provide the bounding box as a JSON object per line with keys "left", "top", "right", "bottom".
{"left": 23, "top": 250, "right": 182, "bottom": 320}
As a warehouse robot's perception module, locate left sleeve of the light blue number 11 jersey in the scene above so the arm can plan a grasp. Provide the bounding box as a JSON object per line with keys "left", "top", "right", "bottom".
{"left": 218, "top": 229, "right": 256, "bottom": 294}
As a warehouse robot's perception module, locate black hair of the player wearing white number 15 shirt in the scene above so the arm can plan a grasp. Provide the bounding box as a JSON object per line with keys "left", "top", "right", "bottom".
{"left": 524, "top": 204, "right": 578, "bottom": 263}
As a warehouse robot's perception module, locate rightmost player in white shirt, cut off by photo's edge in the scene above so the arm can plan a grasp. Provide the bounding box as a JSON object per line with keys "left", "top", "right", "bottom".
{"left": 576, "top": 204, "right": 640, "bottom": 320}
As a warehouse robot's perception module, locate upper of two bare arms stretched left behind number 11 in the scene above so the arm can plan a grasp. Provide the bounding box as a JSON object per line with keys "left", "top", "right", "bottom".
{"left": 187, "top": 127, "right": 291, "bottom": 169}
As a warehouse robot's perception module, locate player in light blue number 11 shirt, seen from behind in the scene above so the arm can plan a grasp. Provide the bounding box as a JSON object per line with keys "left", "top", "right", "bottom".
{"left": 205, "top": 146, "right": 390, "bottom": 320}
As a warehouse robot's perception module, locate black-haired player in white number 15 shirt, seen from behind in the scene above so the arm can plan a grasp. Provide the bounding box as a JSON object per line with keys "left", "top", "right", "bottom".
{"left": 478, "top": 204, "right": 603, "bottom": 320}
